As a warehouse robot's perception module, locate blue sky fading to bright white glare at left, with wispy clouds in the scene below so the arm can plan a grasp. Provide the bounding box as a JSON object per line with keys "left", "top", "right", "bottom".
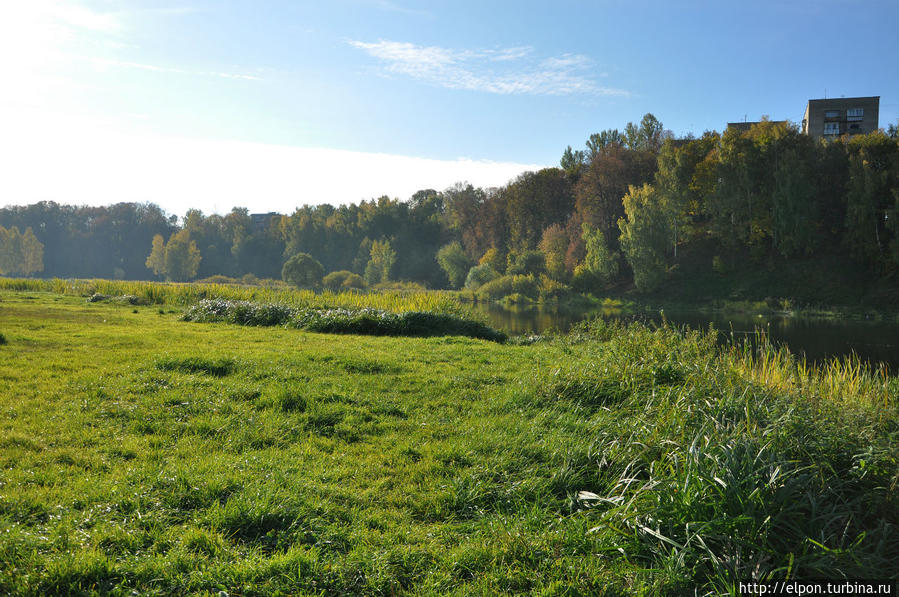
{"left": 0, "top": 0, "right": 899, "bottom": 215}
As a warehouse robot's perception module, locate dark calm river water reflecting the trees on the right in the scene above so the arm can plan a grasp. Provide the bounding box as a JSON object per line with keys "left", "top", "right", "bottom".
{"left": 475, "top": 304, "right": 899, "bottom": 372}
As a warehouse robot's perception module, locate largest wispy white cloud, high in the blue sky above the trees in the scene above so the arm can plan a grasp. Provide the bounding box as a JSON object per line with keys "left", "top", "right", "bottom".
{"left": 348, "top": 40, "right": 630, "bottom": 97}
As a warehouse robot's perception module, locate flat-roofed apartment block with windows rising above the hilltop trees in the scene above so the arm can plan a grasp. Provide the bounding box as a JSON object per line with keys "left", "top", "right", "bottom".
{"left": 802, "top": 95, "right": 880, "bottom": 139}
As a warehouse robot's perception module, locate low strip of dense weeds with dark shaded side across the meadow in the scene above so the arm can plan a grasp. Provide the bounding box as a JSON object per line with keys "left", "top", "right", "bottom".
{"left": 183, "top": 299, "right": 506, "bottom": 342}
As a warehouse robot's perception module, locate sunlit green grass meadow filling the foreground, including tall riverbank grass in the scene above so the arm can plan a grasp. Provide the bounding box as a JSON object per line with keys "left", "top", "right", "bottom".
{"left": 0, "top": 287, "right": 899, "bottom": 596}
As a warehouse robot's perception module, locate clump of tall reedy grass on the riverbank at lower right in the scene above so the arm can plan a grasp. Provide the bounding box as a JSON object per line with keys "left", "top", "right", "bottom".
{"left": 556, "top": 322, "right": 899, "bottom": 593}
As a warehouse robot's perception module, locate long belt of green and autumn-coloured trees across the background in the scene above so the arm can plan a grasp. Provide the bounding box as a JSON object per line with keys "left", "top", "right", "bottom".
{"left": 0, "top": 114, "right": 899, "bottom": 290}
